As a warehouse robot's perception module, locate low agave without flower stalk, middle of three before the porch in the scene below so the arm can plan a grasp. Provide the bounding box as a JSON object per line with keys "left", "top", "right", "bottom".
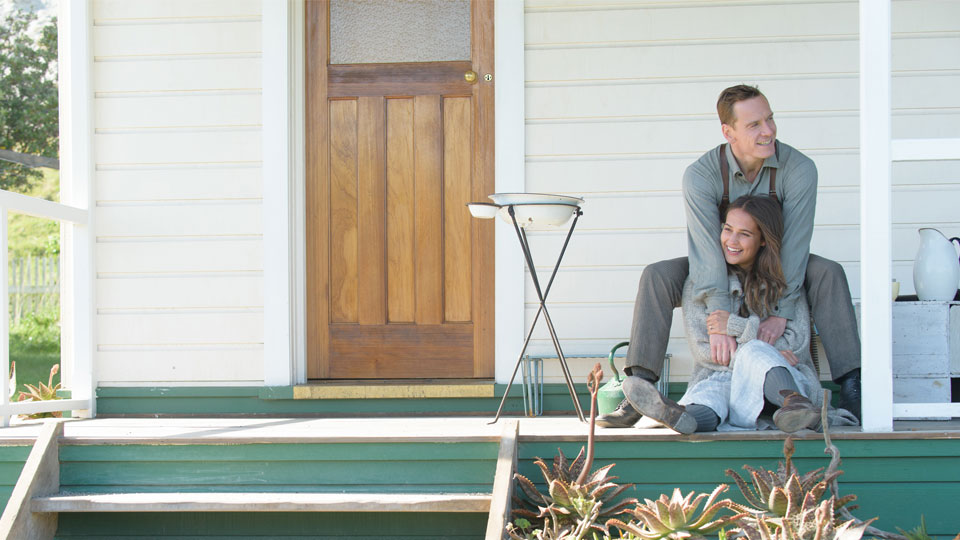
{"left": 607, "top": 484, "right": 747, "bottom": 540}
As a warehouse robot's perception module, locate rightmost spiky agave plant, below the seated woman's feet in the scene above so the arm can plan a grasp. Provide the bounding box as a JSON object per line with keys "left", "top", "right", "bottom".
{"left": 726, "top": 437, "right": 857, "bottom": 523}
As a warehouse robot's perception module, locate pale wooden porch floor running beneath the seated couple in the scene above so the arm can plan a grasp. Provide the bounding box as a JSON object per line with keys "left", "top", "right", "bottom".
{"left": 0, "top": 416, "right": 960, "bottom": 444}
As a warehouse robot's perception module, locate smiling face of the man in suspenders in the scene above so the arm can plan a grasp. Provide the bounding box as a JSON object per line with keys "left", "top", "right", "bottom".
{"left": 723, "top": 96, "right": 777, "bottom": 165}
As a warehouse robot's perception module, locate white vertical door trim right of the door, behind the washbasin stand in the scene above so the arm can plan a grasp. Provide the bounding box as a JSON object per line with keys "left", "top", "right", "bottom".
{"left": 494, "top": 0, "right": 526, "bottom": 384}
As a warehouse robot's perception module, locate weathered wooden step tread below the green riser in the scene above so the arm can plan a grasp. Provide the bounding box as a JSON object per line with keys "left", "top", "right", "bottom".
{"left": 30, "top": 492, "right": 491, "bottom": 513}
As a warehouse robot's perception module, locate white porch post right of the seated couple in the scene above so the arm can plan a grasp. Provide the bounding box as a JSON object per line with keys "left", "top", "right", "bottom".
{"left": 860, "top": 0, "right": 893, "bottom": 432}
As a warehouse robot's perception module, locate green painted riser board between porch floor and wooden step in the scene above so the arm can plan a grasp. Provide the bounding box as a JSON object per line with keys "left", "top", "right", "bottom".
{"left": 60, "top": 442, "right": 499, "bottom": 493}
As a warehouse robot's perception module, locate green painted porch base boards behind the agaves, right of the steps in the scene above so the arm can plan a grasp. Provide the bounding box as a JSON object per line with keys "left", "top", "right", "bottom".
{"left": 518, "top": 439, "right": 960, "bottom": 538}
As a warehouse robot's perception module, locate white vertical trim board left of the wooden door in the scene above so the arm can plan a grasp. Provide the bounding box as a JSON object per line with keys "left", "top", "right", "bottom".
{"left": 262, "top": 0, "right": 306, "bottom": 386}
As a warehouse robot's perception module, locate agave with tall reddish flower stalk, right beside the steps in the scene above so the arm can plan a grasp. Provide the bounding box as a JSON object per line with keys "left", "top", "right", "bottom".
{"left": 507, "top": 364, "right": 637, "bottom": 539}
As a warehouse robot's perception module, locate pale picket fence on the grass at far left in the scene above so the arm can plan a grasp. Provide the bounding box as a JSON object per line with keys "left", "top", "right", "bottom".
{"left": 7, "top": 256, "right": 60, "bottom": 325}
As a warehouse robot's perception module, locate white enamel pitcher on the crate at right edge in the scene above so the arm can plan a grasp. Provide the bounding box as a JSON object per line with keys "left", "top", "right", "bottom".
{"left": 913, "top": 227, "right": 960, "bottom": 302}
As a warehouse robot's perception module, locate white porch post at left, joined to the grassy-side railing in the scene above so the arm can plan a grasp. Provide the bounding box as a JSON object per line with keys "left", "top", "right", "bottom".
{"left": 58, "top": 0, "right": 97, "bottom": 417}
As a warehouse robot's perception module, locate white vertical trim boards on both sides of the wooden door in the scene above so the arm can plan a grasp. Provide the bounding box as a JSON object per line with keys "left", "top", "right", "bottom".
{"left": 261, "top": 0, "right": 525, "bottom": 386}
